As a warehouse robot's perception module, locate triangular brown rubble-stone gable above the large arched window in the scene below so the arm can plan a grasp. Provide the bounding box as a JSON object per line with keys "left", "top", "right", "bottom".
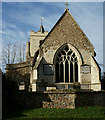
{"left": 41, "top": 9, "right": 94, "bottom": 55}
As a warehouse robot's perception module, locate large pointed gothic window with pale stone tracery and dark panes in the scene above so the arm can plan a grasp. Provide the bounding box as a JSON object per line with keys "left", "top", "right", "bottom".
{"left": 55, "top": 45, "right": 78, "bottom": 83}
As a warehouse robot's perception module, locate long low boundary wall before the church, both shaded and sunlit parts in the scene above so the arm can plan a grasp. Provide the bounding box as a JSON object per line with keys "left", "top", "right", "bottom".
{"left": 5, "top": 90, "right": 105, "bottom": 109}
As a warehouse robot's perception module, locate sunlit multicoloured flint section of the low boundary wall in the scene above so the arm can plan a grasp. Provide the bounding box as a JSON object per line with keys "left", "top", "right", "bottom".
{"left": 43, "top": 93, "right": 76, "bottom": 109}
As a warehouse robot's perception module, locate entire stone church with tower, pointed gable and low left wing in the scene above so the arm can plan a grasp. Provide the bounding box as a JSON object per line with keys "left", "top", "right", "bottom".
{"left": 6, "top": 7, "right": 101, "bottom": 91}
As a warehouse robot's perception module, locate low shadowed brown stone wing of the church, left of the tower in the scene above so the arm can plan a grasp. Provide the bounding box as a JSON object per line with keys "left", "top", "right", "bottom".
{"left": 6, "top": 62, "right": 30, "bottom": 91}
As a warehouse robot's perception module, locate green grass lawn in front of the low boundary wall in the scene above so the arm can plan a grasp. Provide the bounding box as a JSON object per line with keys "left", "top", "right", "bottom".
{"left": 3, "top": 107, "right": 105, "bottom": 120}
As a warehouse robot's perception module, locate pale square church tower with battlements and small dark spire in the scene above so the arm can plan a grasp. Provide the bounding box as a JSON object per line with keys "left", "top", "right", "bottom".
{"left": 26, "top": 23, "right": 48, "bottom": 60}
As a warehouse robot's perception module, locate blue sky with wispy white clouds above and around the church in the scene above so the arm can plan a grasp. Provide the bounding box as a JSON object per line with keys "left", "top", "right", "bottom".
{"left": 2, "top": 2, "right": 103, "bottom": 70}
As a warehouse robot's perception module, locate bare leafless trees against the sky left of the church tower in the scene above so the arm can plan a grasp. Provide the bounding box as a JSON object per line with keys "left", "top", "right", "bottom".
{"left": 1, "top": 43, "right": 25, "bottom": 71}
